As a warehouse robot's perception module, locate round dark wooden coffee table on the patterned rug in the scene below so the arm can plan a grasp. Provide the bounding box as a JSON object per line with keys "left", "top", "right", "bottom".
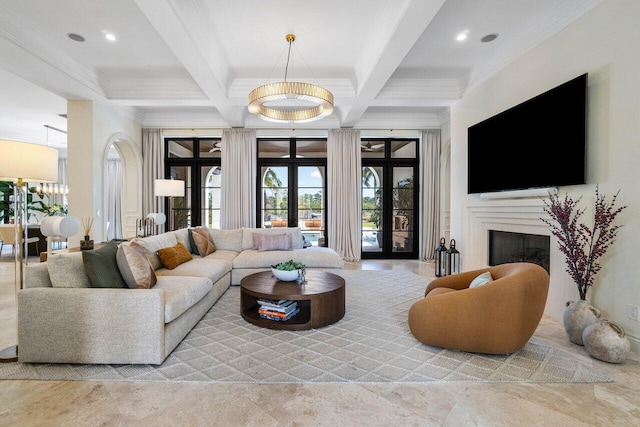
{"left": 240, "top": 270, "right": 344, "bottom": 330}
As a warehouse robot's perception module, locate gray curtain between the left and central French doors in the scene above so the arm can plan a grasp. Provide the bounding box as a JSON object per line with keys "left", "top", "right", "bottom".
{"left": 220, "top": 129, "right": 258, "bottom": 229}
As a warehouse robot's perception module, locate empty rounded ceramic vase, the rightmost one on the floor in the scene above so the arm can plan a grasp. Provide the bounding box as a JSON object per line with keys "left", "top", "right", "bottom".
{"left": 582, "top": 320, "right": 631, "bottom": 363}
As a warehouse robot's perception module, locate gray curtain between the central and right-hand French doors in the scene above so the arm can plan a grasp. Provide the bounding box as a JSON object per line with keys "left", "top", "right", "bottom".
{"left": 327, "top": 129, "right": 362, "bottom": 261}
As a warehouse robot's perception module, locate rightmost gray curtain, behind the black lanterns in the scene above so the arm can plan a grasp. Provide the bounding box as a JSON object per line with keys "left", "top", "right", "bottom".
{"left": 420, "top": 129, "right": 441, "bottom": 261}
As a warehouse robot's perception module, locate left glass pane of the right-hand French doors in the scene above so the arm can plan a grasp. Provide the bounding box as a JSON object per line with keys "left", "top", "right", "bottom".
{"left": 362, "top": 166, "right": 384, "bottom": 252}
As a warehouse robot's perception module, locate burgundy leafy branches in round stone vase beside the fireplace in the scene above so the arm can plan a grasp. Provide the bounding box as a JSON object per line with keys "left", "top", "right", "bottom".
{"left": 540, "top": 186, "right": 626, "bottom": 345}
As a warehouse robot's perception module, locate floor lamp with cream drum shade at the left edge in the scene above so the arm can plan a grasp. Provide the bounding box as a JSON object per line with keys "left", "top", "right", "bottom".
{"left": 0, "top": 141, "right": 58, "bottom": 362}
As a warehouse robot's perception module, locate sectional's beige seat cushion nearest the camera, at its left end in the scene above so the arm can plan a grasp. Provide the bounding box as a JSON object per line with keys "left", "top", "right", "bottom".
{"left": 153, "top": 276, "right": 213, "bottom": 323}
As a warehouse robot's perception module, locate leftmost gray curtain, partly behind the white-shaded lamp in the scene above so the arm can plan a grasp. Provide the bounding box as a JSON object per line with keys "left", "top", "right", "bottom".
{"left": 142, "top": 129, "right": 165, "bottom": 233}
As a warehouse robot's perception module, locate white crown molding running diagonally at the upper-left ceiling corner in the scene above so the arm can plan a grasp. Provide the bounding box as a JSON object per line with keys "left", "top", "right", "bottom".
{"left": 0, "top": 5, "right": 104, "bottom": 97}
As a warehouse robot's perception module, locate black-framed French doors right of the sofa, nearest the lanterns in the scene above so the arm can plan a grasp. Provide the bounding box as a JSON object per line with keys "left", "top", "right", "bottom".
{"left": 361, "top": 139, "right": 418, "bottom": 258}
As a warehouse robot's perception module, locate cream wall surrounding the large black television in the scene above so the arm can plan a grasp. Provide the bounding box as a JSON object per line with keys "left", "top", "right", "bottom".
{"left": 451, "top": 0, "right": 640, "bottom": 352}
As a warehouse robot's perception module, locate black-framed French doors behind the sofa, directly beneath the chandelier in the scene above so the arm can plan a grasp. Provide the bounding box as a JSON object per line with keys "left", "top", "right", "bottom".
{"left": 257, "top": 138, "right": 327, "bottom": 246}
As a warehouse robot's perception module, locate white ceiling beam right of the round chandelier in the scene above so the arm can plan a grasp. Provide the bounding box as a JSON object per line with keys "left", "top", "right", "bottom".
{"left": 342, "top": 0, "right": 445, "bottom": 127}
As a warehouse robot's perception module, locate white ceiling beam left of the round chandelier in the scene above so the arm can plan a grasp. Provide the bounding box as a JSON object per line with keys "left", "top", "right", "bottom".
{"left": 135, "top": 0, "right": 246, "bottom": 126}
